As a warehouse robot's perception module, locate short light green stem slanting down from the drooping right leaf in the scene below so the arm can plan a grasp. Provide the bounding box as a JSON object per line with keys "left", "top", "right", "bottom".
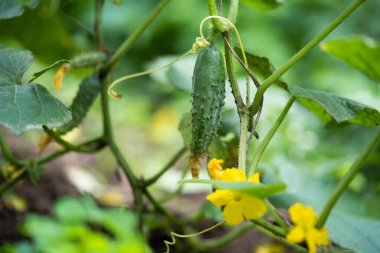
{"left": 248, "top": 96, "right": 296, "bottom": 175}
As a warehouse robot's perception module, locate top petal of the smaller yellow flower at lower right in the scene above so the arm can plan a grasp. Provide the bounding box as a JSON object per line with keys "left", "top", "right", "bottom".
{"left": 289, "top": 203, "right": 317, "bottom": 228}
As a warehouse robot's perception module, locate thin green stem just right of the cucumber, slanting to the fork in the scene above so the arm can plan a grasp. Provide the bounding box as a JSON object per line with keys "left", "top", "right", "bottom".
{"left": 224, "top": 33, "right": 245, "bottom": 115}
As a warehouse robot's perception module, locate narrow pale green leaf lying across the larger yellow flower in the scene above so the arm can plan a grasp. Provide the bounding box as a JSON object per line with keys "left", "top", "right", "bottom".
{"left": 180, "top": 179, "right": 286, "bottom": 198}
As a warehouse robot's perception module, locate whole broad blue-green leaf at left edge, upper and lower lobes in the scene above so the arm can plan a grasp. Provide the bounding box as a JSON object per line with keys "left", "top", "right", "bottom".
{"left": 0, "top": 49, "right": 71, "bottom": 134}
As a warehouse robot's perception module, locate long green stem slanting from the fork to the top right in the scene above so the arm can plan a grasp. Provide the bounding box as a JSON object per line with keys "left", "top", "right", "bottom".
{"left": 252, "top": 0, "right": 365, "bottom": 115}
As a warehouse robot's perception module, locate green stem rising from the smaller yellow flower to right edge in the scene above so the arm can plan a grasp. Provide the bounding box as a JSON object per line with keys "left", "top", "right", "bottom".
{"left": 316, "top": 129, "right": 380, "bottom": 228}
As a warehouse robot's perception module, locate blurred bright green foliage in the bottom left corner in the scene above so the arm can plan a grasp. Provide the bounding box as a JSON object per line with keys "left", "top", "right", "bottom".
{"left": 2, "top": 197, "right": 147, "bottom": 253}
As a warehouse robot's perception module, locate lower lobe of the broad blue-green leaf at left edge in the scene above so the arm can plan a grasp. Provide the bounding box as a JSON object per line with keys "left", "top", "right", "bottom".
{"left": 0, "top": 84, "right": 71, "bottom": 134}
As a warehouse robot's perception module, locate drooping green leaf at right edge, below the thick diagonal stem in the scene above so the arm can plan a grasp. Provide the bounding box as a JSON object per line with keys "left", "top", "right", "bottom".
{"left": 288, "top": 85, "right": 380, "bottom": 126}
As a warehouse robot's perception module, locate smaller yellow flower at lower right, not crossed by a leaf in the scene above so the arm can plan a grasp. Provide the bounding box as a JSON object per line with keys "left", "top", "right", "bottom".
{"left": 286, "top": 203, "right": 329, "bottom": 253}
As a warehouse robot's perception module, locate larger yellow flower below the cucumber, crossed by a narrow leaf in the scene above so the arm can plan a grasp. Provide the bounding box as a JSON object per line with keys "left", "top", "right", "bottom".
{"left": 206, "top": 163, "right": 267, "bottom": 225}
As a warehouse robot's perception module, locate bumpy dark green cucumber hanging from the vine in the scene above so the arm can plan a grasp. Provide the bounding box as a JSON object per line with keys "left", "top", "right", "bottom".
{"left": 190, "top": 45, "right": 226, "bottom": 157}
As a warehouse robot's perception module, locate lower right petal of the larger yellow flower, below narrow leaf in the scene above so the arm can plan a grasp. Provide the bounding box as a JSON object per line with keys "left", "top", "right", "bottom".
{"left": 239, "top": 194, "right": 268, "bottom": 220}
